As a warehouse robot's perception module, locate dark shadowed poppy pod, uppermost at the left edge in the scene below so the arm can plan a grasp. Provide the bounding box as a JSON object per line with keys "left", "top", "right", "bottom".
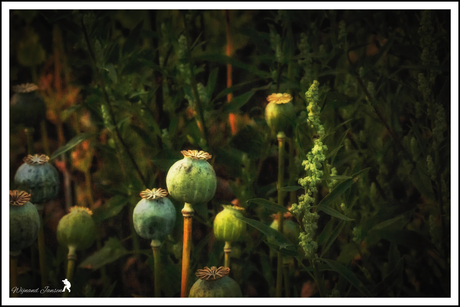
{"left": 10, "top": 83, "right": 46, "bottom": 127}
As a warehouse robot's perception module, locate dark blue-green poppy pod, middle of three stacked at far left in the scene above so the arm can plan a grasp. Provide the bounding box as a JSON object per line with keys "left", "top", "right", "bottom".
{"left": 14, "top": 154, "right": 59, "bottom": 204}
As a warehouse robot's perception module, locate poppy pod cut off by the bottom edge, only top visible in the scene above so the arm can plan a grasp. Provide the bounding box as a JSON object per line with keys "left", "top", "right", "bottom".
{"left": 189, "top": 266, "right": 243, "bottom": 297}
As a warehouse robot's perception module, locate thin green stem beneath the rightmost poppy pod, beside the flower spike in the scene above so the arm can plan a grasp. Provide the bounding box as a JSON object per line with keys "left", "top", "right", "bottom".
{"left": 276, "top": 132, "right": 286, "bottom": 297}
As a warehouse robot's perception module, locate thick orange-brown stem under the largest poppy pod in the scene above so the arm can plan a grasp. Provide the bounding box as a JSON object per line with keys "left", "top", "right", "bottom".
{"left": 180, "top": 203, "right": 195, "bottom": 297}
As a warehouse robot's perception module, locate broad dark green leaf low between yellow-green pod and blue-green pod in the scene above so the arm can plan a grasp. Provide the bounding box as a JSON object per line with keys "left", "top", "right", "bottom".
{"left": 78, "top": 237, "right": 129, "bottom": 270}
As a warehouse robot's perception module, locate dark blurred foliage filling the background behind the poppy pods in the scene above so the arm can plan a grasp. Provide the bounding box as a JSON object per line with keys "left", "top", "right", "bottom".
{"left": 10, "top": 10, "right": 451, "bottom": 297}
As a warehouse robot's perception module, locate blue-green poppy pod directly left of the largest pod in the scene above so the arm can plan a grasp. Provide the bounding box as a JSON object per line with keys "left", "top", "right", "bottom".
{"left": 133, "top": 189, "right": 176, "bottom": 242}
